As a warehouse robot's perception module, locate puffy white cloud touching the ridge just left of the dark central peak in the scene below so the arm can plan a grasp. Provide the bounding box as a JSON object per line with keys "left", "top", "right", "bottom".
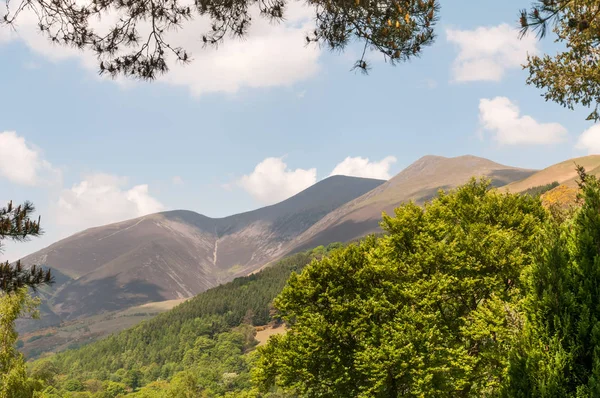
{"left": 238, "top": 158, "right": 317, "bottom": 204}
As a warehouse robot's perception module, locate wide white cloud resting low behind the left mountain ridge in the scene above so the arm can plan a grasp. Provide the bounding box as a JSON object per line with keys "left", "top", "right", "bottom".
{"left": 56, "top": 173, "right": 164, "bottom": 232}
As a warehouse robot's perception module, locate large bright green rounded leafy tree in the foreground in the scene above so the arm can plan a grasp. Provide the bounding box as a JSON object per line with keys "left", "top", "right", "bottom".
{"left": 254, "top": 180, "right": 546, "bottom": 397}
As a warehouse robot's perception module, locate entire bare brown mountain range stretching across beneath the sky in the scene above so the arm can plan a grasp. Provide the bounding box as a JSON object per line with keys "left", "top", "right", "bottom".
{"left": 16, "top": 155, "right": 600, "bottom": 346}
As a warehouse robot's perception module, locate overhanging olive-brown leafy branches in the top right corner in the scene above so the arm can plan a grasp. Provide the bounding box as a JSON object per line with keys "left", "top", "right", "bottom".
{"left": 521, "top": 0, "right": 600, "bottom": 121}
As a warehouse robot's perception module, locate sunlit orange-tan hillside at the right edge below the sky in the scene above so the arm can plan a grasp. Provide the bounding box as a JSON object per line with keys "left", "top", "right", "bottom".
{"left": 506, "top": 155, "right": 600, "bottom": 192}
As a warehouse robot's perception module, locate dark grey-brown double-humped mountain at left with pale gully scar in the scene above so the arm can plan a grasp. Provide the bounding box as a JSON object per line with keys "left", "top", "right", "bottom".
{"left": 23, "top": 176, "right": 384, "bottom": 321}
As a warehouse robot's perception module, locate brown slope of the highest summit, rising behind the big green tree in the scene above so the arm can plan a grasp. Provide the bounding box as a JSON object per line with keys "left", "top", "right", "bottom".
{"left": 276, "top": 155, "right": 535, "bottom": 253}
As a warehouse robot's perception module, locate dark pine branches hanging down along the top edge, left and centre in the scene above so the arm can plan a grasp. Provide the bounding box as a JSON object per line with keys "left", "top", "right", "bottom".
{"left": 2, "top": 0, "right": 439, "bottom": 79}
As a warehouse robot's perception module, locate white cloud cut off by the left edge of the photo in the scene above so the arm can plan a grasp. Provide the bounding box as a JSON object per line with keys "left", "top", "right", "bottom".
{"left": 0, "top": 131, "right": 60, "bottom": 186}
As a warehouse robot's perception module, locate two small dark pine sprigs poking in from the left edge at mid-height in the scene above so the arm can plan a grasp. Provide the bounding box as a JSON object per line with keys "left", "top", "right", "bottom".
{"left": 0, "top": 202, "right": 53, "bottom": 294}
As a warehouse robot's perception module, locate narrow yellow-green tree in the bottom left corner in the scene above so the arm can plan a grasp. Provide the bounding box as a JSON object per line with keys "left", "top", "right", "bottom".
{"left": 0, "top": 288, "right": 39, "bottom": 398}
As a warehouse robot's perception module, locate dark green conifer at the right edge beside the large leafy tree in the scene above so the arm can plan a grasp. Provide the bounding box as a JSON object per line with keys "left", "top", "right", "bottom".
{"left": 506, "top": 167, "right": 600, "bottom": 398}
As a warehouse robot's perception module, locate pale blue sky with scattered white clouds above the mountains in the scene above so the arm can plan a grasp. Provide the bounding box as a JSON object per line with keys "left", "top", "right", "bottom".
{"left": 0, "top": 0, "right": 600, "bottom": 261}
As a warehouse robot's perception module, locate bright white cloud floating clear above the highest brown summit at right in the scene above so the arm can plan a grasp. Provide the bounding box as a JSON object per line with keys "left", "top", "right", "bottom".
{"left": 479, "top": 97, "right": 567, "bottom": 145}
